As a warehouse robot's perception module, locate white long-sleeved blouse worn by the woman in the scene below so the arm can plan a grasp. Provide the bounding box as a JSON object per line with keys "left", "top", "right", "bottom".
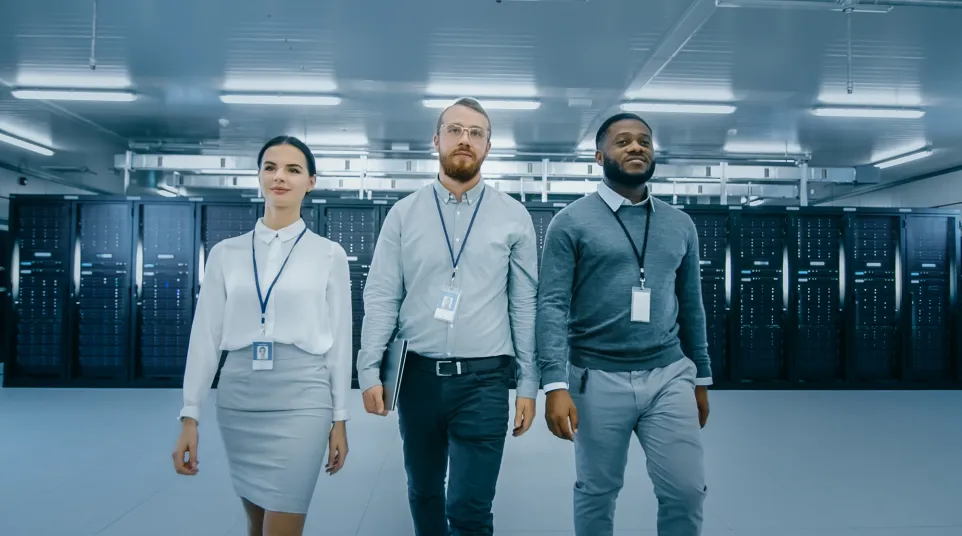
{"left": 180, "top": 220, "right": 353, "bottom": 422}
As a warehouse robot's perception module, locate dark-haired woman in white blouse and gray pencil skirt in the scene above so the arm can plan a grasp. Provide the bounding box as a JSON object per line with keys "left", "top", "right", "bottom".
{"left": 173, "top": 136, "right": 352, "bottom": 536}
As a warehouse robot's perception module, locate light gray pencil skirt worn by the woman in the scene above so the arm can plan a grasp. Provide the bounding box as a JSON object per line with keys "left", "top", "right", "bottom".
{"left": 217, "top": 344, "right": 334, "bottom": 514}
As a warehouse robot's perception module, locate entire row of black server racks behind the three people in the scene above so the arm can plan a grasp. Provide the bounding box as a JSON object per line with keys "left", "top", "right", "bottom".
{"left": 0, "top": 196, "right": 962, "bottom": 388}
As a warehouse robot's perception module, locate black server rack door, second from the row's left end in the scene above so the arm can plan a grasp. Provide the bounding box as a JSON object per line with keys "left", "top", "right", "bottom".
{"left": 71, "top": 201, "right": 134, "bottom": 380}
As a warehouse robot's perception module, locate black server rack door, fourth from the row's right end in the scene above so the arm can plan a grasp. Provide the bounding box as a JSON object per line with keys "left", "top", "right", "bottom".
{"left": 732, "top": 214, "right": 787, "bottom": 381}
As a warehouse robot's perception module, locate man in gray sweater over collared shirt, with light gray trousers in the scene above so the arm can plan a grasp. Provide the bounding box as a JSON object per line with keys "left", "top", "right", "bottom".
{"left": 536, "top": 114, "right": 711, "bottom": 536}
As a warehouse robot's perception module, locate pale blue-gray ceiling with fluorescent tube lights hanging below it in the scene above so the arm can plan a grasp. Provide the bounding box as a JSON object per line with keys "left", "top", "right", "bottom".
{"left": 0, "top": 0, "right": 962, "bottom": 191}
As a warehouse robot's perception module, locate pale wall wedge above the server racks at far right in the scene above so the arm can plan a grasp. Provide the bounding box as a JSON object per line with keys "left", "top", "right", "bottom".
{"left": 824, "top": 171, "right": 962, "bottom": 208}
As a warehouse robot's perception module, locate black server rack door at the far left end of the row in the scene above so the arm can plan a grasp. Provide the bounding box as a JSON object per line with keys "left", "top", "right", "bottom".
{"left": 4, "top": 200, "right": 73, "bottom": 382}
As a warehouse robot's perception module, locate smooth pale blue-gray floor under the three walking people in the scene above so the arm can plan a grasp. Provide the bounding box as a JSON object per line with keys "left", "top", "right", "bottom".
{"left": 0, "top": 389, "right": 962, "bottom": 536}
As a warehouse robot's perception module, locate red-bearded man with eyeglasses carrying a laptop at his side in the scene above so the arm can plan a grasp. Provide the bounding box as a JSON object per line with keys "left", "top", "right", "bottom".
{"left": 357, "top": 98, "right": 540, "bottom": 536}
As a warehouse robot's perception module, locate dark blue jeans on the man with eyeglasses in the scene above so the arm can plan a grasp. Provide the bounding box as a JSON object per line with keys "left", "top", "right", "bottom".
{"left": 398, "top": 358, "right": 509, "bottom": 536}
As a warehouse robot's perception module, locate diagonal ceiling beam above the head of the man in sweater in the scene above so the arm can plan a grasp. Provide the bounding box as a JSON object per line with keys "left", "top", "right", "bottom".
{"left": 579, "top": 0, "right": 717, "bottom": 152}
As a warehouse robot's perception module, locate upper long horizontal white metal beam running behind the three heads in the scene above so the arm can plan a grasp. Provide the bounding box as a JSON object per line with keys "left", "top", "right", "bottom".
{"left": 114, "top": 154, "right": 855, "bottom": 182}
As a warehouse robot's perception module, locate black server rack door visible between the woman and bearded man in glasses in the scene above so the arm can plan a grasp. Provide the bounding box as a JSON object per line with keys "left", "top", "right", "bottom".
{"left": 321, "top": 203, "right": 386, "bottom": 387}
